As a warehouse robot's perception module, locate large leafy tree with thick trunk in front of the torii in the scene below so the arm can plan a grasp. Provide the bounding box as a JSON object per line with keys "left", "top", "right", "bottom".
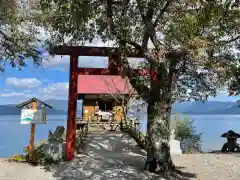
{"left": 36, "top": 0, "right": 240, "bottom": 173}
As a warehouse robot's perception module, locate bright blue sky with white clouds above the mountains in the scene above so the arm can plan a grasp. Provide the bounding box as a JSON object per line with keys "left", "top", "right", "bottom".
{"left": 0, "top": 41, "right": 239, "bottom": 104}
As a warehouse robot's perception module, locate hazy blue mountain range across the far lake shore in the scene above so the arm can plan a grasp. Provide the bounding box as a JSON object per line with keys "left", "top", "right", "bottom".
{"left": 0, "top": 99, "right": 240, "bottom": 116}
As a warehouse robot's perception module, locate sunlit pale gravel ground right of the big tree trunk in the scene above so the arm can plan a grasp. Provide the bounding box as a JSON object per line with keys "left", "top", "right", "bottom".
{"left": 173, "top": 154, "right": 240, "bottom": 180}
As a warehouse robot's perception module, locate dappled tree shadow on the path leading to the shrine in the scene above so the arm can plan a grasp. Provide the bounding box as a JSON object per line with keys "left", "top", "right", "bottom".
{"left": 44, "top": 132, "right": 195, "bottom": 180}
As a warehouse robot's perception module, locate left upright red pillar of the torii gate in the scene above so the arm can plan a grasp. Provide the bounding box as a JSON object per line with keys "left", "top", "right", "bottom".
{"left": 66, "top": 55, "right": 78, "bottom": 161}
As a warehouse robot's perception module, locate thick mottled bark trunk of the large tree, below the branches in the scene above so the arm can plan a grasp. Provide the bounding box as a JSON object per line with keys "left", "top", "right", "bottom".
{"left": 145, "top": 101, "right": 174, "bottom": 172}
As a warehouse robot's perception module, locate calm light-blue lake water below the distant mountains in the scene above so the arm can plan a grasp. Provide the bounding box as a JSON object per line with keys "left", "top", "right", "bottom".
{"left": 0, "top": 115, "right": 240, "bottom": 158}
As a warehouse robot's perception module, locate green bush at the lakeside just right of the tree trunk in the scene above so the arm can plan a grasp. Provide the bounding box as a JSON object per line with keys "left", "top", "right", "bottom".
{"left": 172, "top": 116, "right": 202, "bottom": 153}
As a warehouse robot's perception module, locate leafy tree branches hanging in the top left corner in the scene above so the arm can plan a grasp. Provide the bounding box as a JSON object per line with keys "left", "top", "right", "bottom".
{"left": 0, "top": 0, "right": 43, "bottom": 72}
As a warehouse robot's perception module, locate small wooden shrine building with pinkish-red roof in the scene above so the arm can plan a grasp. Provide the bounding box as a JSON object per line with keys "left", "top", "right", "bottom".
{"left": 78, "top": 75, "right": 134, "bottom": 123}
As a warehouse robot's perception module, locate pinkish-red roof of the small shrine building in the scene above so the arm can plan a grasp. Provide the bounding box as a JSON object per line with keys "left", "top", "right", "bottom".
{"left": 77, "top": 75, "right": 134, "bottom": 95}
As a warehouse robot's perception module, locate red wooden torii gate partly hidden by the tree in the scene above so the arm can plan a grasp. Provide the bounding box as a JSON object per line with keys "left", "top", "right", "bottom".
{"left": 51, "top": 46, "right": 151, "bottom": 161}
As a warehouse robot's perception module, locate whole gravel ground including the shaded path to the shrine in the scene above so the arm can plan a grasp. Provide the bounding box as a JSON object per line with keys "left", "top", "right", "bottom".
{"left": 0, "top": 132, "right": 240, "bottom": 180}
